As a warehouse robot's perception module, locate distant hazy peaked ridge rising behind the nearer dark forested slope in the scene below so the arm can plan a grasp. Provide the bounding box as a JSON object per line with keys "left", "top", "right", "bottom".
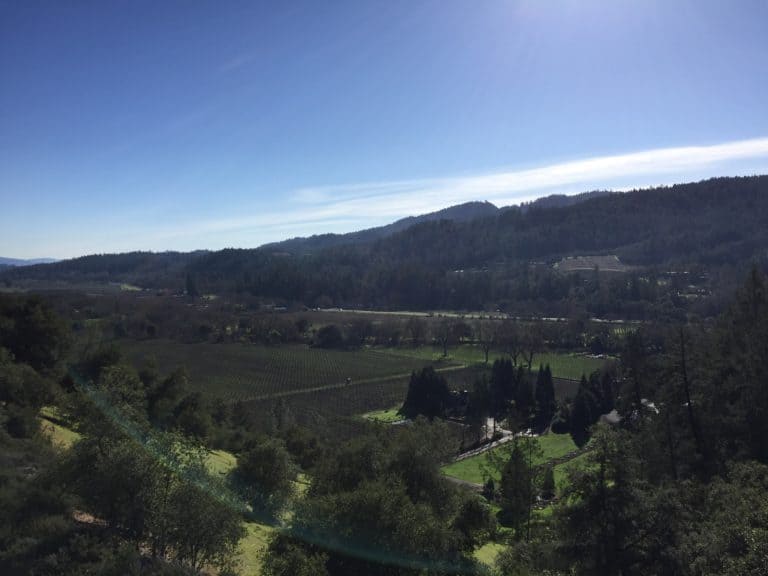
{"left": 261, "top": 202, "right": 499, "bottom": 254}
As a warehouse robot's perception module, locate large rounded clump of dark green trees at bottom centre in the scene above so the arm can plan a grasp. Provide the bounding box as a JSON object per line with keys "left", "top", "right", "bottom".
{"left": 267, "top": 419, "right": 480, "bottom": 575}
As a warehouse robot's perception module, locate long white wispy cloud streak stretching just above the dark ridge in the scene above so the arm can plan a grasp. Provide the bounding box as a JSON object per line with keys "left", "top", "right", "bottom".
{"left": 163, "top": 138, "right": 768, "bottom": 248}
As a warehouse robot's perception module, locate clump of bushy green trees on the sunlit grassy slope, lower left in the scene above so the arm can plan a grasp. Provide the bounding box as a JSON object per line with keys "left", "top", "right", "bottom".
{"left": 65, "top": 430, "right": 243, "bottom": 570}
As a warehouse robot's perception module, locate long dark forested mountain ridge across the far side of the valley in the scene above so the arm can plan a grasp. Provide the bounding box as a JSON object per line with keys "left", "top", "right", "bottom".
{"left": 6, "top": 176, "right": 768, "bottom": 318}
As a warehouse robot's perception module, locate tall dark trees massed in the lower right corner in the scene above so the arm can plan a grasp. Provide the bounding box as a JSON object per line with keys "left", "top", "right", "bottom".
{"left": 486, "top": 271, "right": 768, "bottom": 576}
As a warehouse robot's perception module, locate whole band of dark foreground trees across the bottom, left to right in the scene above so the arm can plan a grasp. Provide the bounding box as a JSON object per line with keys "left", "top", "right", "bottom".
{"left": 0, "top": 270, "right": 768, "bottom": 576}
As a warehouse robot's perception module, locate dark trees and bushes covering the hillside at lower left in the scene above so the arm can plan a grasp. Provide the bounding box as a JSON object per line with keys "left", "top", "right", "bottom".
{"left": 0, "top": 294, "right": 317, "bottom": 575}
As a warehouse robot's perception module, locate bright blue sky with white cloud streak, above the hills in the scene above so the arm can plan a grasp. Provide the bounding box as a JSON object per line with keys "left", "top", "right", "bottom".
{"left": 0, "top": 0, "right": 768, "bottom": 258}
